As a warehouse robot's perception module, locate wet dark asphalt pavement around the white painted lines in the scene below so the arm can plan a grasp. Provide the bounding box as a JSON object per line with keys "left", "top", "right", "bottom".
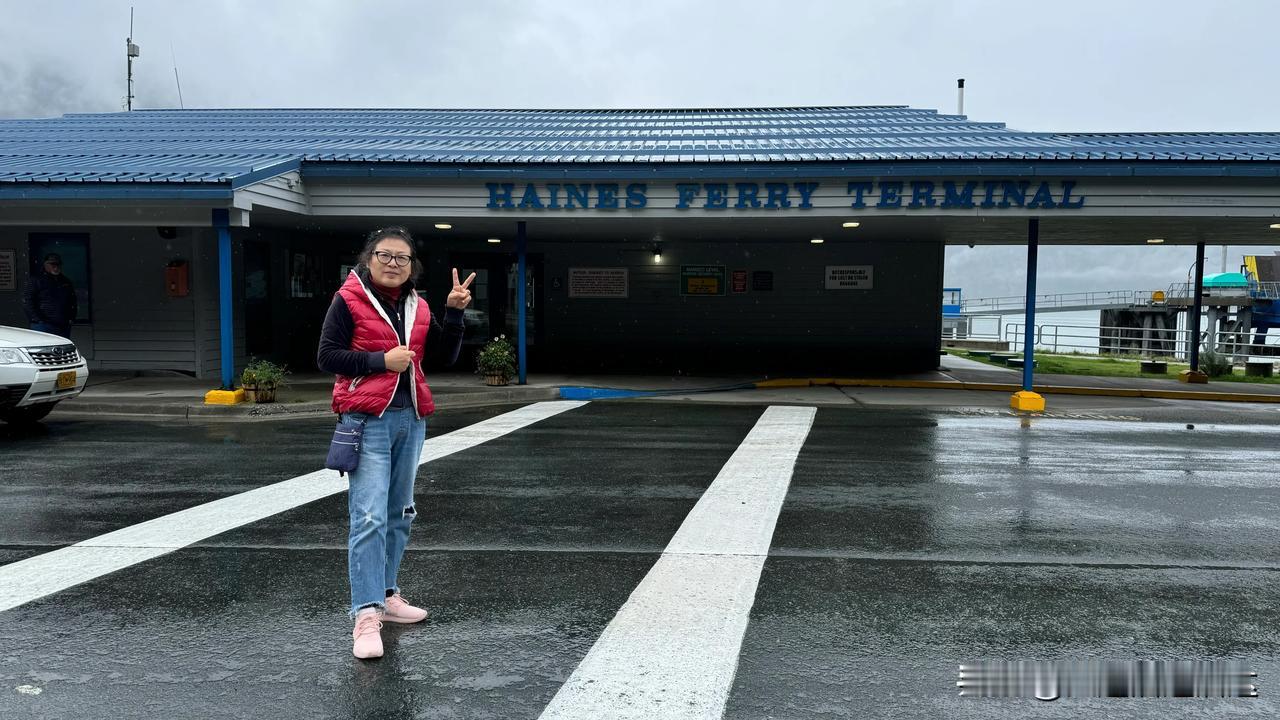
{"left": 0, "top": 401, "right": 1280, "bottom": 720}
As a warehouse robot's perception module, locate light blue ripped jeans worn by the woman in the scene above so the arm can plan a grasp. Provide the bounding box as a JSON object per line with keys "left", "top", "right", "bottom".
{"left": 343, "top": 407, "right": 426, "bottom": 616}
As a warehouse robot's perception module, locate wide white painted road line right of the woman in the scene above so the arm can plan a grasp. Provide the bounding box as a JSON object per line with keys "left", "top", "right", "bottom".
{"left": 541, "top": 406, "right": 817, "bottom": 720}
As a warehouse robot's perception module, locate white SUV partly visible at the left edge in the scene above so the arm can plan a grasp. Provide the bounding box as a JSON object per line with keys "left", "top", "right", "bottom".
{"left": 0, "top": 325, "right": 88, "bottom": 423}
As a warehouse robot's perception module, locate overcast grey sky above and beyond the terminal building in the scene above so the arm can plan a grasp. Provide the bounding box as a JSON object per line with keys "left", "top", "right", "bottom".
{"left": 0, "top": 0, "right": 1280, "bottom": 296}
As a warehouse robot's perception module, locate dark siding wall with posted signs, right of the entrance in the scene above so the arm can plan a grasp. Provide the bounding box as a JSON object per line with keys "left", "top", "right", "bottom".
{"left": 530, "top": 240, "right": 942, "bottom": 374}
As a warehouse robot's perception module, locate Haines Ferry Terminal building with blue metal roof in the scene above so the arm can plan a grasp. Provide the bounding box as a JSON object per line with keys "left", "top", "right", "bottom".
{"left": 0, "top": 106, "right": 1280, "bottom": 384}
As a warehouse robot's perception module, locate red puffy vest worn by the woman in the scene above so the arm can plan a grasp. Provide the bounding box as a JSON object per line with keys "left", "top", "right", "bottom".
{"left": 333, "top": 270, "right": 435, "bottom": 418}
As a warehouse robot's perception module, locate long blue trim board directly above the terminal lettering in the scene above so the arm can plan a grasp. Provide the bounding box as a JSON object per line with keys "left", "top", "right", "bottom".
{"left": 302, "top": 160, "right": 1280, "bottom": 181}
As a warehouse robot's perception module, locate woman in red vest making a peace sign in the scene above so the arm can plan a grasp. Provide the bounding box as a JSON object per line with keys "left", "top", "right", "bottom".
{"left": 317, "top": 227, "right": 476, "bottom": 659}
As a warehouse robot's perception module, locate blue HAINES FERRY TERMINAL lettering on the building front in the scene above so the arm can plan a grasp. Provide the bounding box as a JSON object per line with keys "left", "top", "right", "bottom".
{"left": 485, "top": 179, "right": 1085, "bottom": 210}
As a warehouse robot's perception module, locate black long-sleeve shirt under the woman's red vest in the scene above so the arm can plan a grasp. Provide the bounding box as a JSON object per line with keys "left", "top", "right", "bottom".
{"left": 316, "top": 288, "right": 466, "bottom": 407}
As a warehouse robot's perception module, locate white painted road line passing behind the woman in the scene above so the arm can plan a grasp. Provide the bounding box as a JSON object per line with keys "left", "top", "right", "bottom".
{"left": 0, "top": 400, "right": 586, "bottom": 612}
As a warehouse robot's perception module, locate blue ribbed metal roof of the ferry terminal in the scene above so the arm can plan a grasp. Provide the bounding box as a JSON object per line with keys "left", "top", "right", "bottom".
{"left": 0, "top": 106, "right": 1280, "bottom": 187}
